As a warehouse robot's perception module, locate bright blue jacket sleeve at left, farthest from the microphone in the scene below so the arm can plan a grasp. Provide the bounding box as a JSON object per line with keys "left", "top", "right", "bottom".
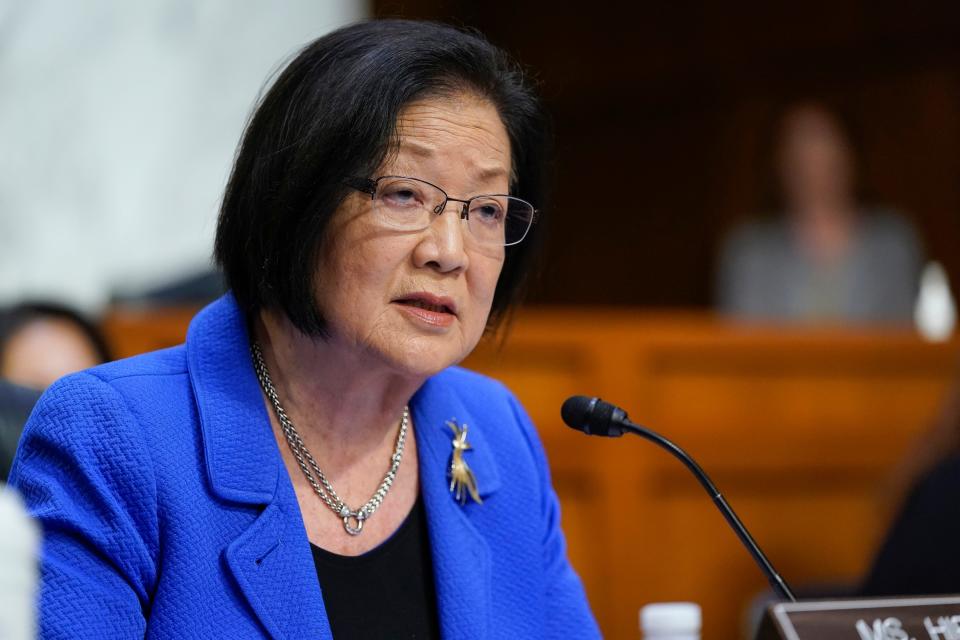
{"left": 10, "top": 373, "right": 158, "bottom": 640}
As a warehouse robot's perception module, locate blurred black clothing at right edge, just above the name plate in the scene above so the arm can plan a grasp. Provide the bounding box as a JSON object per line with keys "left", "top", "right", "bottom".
{"left": 862, "top": 456, "right": 960, "bottom": 596}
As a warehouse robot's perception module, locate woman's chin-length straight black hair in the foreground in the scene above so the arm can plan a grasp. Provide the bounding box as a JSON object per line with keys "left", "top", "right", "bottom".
{"left": 215, "top": 20, "right": 550, "bottom": 336}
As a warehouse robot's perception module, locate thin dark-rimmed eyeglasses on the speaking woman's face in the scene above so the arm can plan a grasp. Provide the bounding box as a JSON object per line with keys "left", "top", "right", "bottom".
{"left": 346, "top": 176, "right": 537, "bottom": 247}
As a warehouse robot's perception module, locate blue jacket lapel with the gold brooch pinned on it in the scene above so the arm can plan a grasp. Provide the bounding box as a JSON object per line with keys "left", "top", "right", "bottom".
{"left": 411, "top": 379, "right": 500, "bottom": 638}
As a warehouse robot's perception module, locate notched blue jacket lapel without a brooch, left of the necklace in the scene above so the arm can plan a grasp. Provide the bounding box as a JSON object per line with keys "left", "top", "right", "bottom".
{"left": 187, "top": 294, "right": 332, "bottom": 638}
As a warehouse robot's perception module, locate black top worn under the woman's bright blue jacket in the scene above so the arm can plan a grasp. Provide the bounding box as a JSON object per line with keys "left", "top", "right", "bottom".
{"left": 310, "top": 497, "right": 440, "bottom": 640}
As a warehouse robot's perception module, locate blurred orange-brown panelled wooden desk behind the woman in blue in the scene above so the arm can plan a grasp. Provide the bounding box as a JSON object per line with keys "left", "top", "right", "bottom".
{"left": 106, "top": 308, "right": 960, "bottom": 640}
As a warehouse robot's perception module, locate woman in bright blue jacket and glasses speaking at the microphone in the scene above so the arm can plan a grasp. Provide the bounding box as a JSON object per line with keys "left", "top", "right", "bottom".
{"left": 12, "top": 21, "right": 598, "bottom": 638}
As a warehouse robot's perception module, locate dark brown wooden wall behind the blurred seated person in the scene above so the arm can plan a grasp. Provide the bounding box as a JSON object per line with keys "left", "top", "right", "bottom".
{"left": 374, "top": 0, "right": 960, "bottom": 306}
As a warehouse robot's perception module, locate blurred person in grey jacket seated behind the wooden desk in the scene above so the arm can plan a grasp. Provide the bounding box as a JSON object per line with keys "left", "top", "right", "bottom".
{"left": 717, "top": 103, "right": 923, "bottom": 323}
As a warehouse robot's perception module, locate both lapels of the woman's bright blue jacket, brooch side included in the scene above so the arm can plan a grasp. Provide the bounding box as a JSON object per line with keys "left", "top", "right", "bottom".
{"left": 187, "top": 294, "right": 500, "bottom": 639}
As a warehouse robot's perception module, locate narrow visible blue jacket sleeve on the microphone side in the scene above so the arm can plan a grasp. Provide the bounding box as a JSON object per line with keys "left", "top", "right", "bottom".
{"left": 502, "top": 395, "right": 600, "bottom": 638}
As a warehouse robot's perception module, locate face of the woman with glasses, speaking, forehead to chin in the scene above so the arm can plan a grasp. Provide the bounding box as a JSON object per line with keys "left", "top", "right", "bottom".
{"left": 316, "top": 93, "right": 511, "bottom": 376}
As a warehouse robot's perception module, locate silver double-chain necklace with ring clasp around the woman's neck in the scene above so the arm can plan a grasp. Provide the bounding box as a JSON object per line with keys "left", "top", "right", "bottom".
{"left": 250, "top": 342, "right": 410, "bottom": 536}
